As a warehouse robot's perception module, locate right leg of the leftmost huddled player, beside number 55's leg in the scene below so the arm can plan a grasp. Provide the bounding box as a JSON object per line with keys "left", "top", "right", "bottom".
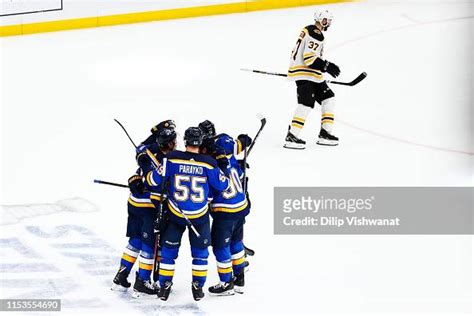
{"left": 133, "top": 209, "right": 158, "bottom": 297}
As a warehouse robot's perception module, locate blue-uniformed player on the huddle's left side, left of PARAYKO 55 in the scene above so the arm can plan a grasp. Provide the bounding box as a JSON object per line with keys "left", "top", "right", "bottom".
{"left": 112, "top": 121, "right": 176, "bottom": 297}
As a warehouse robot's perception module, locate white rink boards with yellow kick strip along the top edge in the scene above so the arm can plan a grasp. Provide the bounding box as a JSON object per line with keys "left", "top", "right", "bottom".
{"left": 0, "top": 0, "right": 351, "bottom": 36}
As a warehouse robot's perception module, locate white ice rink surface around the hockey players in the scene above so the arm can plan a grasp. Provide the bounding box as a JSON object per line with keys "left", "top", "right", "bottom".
{"left": 0, "top": 1, "right": 474, "bottom": 315}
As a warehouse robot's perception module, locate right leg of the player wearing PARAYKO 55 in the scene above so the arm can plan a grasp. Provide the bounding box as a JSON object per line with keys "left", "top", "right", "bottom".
{"left": 189, "top": 215, "right": 211, "bottom": 301}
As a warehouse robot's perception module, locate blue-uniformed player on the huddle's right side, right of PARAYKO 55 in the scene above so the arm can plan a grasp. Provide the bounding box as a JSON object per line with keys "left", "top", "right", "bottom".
{"left": 199, "top": 121, "right": 251, "bottom": 295}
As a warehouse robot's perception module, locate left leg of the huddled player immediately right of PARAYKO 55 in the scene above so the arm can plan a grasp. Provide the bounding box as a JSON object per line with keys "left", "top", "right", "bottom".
{"left": 209, "top": 219, "right": 234, "bottom": 295}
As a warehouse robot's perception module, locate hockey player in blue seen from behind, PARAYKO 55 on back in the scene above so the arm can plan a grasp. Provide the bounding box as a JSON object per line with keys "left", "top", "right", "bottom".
{"left": 146, "top": 127, "right": 229, "bottom": 301}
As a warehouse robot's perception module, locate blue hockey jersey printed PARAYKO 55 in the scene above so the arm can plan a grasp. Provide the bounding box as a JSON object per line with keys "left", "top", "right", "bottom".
{"left": 146, "top": 150, "right": 229, "bottom": 225}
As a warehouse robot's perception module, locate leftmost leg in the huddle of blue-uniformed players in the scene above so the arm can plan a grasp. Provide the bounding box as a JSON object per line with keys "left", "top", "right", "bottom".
{"left": 112, "top": 204, "right": 142, "bottom": 292}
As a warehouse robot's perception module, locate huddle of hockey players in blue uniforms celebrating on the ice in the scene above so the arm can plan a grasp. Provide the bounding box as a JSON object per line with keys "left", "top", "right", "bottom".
{"left": 112, "top": 120, "right": 252, "bottom": 301}
